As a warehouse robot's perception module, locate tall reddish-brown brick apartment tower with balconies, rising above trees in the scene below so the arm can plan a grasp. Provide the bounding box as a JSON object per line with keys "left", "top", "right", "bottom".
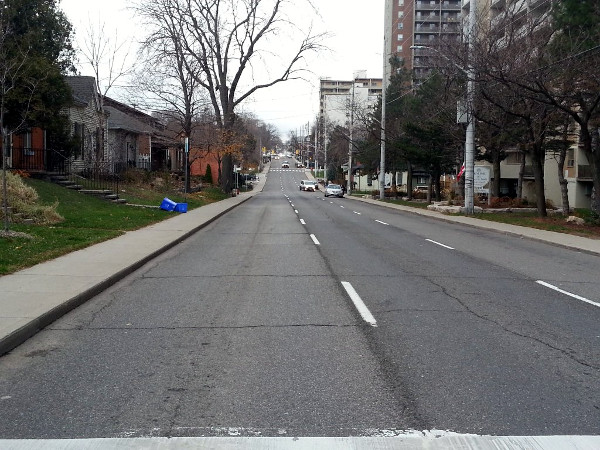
{"left": 385, "top": 0, "right": 462, "bottom": 81}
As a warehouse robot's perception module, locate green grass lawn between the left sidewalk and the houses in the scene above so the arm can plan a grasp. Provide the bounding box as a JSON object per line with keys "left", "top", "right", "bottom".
{"left": 0, "top": 179, "right": 226, "bottom": 275}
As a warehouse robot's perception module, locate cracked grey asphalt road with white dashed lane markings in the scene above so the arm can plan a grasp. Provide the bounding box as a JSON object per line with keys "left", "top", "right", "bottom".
{"left": 0, "top": 163, "right": 600, "bottom": 438}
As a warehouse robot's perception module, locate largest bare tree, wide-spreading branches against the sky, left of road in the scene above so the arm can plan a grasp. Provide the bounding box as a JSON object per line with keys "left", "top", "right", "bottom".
{"left": 139, "top": 0, "right": 323, "bottom": 192}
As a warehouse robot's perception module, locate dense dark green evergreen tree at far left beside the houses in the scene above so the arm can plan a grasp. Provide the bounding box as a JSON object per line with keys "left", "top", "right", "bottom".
{"left": 0, "top": 0, "right": 74, "bottom": 134}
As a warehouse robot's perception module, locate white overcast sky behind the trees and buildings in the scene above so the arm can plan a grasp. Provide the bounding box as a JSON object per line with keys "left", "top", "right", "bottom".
{"left": 60, "top": 0, "right": 385, "bottom": 140}
